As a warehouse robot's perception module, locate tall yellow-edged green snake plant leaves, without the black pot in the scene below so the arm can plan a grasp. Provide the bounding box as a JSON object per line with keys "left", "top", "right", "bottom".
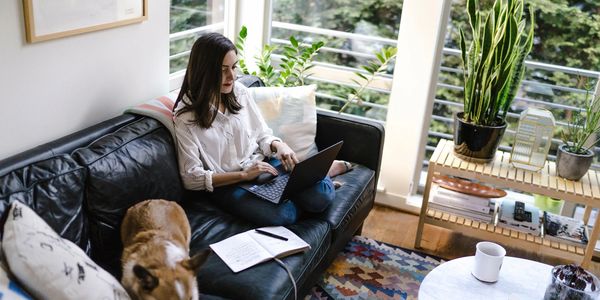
{"left": 460, "top": 0, "right": 535, "bottom": 126}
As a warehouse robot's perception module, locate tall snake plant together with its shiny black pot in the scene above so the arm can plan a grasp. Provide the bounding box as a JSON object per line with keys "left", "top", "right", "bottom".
{"left": 454, "top": 0, "right": 534, "bottom": 162}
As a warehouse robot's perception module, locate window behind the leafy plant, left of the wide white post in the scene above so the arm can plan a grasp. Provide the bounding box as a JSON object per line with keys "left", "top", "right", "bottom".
{"left": 271, "top": 0, "right": 402, "bottom": 121}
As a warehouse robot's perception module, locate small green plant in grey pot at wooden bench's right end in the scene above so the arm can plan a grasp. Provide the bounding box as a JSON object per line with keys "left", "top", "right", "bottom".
{"left": 556, "top": 90, "right": 600, "bottom": 180}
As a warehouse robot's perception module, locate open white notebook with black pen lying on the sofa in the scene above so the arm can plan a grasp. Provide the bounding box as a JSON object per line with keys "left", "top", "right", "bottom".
{"left": 210, "top": 226, "right": 310, "bottom": 273}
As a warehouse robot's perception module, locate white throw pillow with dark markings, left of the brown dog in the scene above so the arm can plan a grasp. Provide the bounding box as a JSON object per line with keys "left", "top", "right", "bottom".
{"left": 2, "top": 201, "right": 129, "bottom": 299}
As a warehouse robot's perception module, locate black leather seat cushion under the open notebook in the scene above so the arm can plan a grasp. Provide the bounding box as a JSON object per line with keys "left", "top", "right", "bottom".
{"left": 182, "top": 199, "right": 331, "bottom": 299}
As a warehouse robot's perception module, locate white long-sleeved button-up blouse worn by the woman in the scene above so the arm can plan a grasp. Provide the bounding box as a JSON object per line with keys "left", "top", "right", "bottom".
{"left": 174, "top": 83, "right": 280, "bottom": 192}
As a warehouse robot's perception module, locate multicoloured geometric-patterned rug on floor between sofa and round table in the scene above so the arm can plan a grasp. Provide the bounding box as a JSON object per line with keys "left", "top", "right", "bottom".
{"left": 305, "top": 236, "right": 445, "bottom": 300}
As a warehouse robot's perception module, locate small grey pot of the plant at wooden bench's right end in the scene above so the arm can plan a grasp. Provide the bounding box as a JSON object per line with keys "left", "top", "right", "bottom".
{"left": 556, "top": 144, "right": 594, "bottom": 181}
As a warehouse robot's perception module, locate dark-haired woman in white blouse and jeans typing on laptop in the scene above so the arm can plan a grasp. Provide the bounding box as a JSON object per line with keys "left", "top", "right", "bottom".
{"left": 174, "top": 33, "right": 347, "bottom": 225}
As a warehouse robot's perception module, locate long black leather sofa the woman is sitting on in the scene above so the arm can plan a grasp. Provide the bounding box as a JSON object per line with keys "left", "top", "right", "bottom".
{"left": 0, "top": 78, "right": 384, "bottom": 299}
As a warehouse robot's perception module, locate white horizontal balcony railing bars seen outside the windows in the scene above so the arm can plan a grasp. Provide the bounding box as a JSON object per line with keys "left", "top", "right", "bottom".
{"left": 170, "top": 21, "right": 600, "bottom": 169}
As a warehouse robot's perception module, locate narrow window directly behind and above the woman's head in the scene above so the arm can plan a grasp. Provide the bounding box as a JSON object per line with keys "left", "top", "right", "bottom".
{"left": 169, "top": 0, "right": 225, "bottom": 74}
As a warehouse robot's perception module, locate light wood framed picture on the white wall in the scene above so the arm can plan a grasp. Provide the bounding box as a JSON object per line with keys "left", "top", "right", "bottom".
{"left": 23, "top": 0, "right": 148, "bottom": 43}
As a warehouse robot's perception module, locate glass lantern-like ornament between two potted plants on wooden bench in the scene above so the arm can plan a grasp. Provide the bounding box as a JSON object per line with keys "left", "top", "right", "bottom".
{"left": 510, "top": 107, "right": 555, "bottom": 171}
